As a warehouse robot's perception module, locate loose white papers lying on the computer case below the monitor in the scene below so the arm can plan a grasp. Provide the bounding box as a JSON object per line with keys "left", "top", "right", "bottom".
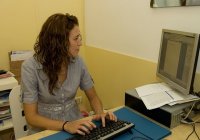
{"left": 136, "top": 83, "right": 199, "bottom": 110}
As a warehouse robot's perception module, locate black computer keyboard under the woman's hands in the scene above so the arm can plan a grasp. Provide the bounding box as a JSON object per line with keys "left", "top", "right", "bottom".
{"left": 66, "top": 120, "right": 135, "bottom": 140}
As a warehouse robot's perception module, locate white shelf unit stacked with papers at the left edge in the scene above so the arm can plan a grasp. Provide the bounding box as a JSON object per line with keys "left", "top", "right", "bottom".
{"left": 0, "top": 77, "right": 18, "bottom": 131}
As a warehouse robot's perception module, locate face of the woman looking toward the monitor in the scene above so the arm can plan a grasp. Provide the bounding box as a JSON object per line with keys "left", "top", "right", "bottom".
{"left": 69, "top": 26, "right": 82, "bottom": 57}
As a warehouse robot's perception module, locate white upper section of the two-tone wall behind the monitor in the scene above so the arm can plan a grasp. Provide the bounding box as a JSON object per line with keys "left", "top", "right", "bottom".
{"left": 85, "top": 0, "right": 200, "bottom": 71}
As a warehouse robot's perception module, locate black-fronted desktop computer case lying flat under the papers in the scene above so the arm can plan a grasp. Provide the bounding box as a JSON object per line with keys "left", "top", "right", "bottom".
{"left": 125, "top": 89, "right": 193, "bottom": 128}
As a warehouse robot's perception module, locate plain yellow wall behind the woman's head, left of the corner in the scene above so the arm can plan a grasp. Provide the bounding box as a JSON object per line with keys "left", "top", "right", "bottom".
{"left": 0, "top": 0, "right": 84, "bottom": 70}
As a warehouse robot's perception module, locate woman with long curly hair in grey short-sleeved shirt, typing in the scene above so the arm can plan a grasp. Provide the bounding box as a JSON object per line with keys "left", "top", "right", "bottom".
{"left": 21, "top": 14, "right": 117, "bottom": 135}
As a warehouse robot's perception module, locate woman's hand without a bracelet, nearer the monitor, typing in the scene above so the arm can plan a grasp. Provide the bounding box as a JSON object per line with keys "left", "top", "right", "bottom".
{"left": 93, "top": 111, "right": 117, "bottom": 127}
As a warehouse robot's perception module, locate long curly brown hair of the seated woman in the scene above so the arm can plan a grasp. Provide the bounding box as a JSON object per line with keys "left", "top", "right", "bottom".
{"left": 34, "top": 13, "right": 79, "bottom": 95}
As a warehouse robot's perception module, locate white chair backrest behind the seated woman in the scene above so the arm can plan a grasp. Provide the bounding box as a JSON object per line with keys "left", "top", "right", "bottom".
{"left": 9, "top": 85, "right": 28, "bottom": 139}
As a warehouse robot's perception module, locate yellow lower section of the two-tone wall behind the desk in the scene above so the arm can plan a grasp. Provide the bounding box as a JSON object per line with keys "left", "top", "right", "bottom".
{"left": 86, "top": 46, "right": 200, "bottom": 109}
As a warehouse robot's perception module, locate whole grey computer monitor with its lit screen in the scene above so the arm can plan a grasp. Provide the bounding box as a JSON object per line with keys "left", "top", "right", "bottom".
{"left": 156, "top": 29, "right": 200, "bottom": 94}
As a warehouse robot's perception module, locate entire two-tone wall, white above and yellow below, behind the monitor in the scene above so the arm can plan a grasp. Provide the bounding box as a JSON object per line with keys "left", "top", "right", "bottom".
{"left": 85, "top": 0, "right": 200, "bottom": 108}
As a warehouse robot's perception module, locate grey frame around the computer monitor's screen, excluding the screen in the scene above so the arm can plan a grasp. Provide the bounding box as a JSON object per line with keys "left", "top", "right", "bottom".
{"left": 156, "top": 29, "right": 200, "bottom": 94}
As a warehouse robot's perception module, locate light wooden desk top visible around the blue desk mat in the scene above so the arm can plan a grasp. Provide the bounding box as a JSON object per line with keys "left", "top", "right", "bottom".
{"left": 19, "top": 107, "right": 200, "bottom": 140}
